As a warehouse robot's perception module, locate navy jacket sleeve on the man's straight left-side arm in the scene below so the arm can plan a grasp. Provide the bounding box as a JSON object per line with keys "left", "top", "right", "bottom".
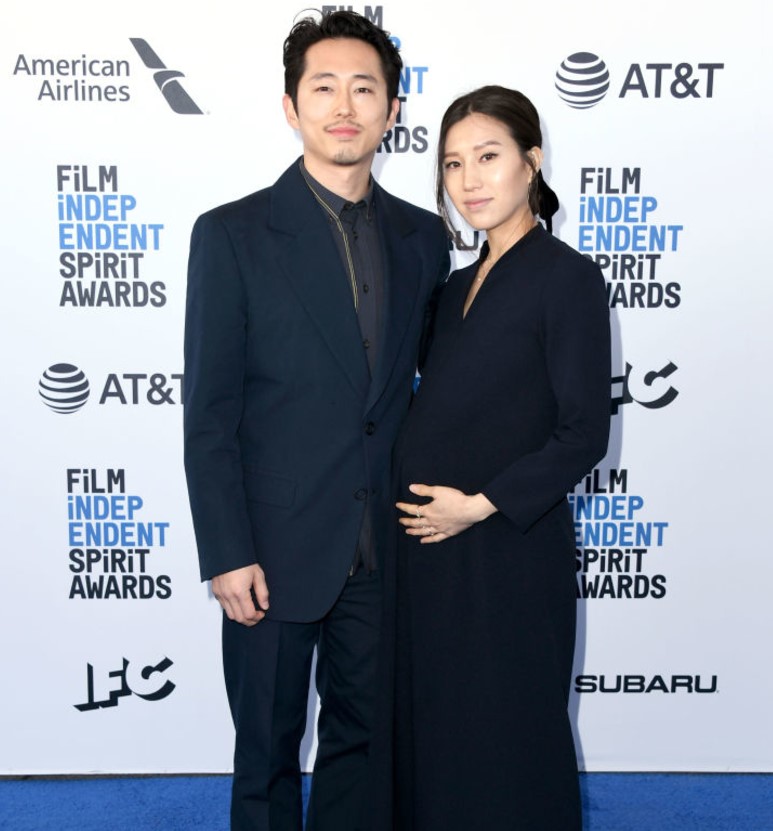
{"left": 184, "top": 212, "right": 255, "bottom": 580}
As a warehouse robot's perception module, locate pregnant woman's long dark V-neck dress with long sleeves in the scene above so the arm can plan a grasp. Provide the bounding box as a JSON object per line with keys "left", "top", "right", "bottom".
{"left": 373, "top": 225, "right": 610, "bottom": 831}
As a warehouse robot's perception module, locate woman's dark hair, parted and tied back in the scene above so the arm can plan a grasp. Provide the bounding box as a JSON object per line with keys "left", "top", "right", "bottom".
{"left": 436, "top": 86, "right": 558, "bottom": 235}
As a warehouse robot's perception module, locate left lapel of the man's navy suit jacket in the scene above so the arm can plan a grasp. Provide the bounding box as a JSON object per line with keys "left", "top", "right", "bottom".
{"left": 270, "top": 163, "right": 369, "bottom": 396}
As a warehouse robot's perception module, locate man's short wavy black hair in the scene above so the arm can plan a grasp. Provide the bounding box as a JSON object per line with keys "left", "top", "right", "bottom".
{"left": 284, "top": 11, "right": 403, "bottom": 109}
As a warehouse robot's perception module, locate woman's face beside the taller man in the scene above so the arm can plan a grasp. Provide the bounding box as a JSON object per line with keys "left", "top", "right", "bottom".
{"left": 443, "top": 113, "right": 542, "bottom": 235}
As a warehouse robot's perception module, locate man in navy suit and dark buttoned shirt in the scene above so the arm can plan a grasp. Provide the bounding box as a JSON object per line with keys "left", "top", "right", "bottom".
{"left": 185, "top": 12, "right": 448, "bottom": 831}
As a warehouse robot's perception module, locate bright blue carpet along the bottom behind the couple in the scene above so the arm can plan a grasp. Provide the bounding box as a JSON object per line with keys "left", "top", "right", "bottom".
{"left": 0, "top": 773, "right": 773, "bottom": 831}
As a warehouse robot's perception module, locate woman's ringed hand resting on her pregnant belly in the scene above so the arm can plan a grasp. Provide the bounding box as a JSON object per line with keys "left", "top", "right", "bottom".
{"left": 397, "top": 485, "right": 497, "bottom": 543}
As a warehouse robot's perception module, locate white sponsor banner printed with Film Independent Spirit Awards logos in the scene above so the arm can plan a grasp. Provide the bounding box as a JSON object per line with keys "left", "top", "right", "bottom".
{"left": 0, "top": 0, "right": 773, "bottom": 774}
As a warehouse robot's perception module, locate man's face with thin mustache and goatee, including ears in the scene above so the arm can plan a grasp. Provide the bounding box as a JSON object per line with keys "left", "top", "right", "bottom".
{"left": 282, "top": 38, "right": 399, "bottom": 174}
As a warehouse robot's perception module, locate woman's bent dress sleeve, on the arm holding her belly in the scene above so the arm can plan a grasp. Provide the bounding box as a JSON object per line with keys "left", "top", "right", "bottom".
{"left": 483, "top": 253, "right": 611, "bottom": 531}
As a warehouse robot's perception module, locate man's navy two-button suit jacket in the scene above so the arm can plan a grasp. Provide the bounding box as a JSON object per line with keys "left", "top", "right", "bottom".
{"left": 184, "top": 163, "right": 448, "bottom": 622}
